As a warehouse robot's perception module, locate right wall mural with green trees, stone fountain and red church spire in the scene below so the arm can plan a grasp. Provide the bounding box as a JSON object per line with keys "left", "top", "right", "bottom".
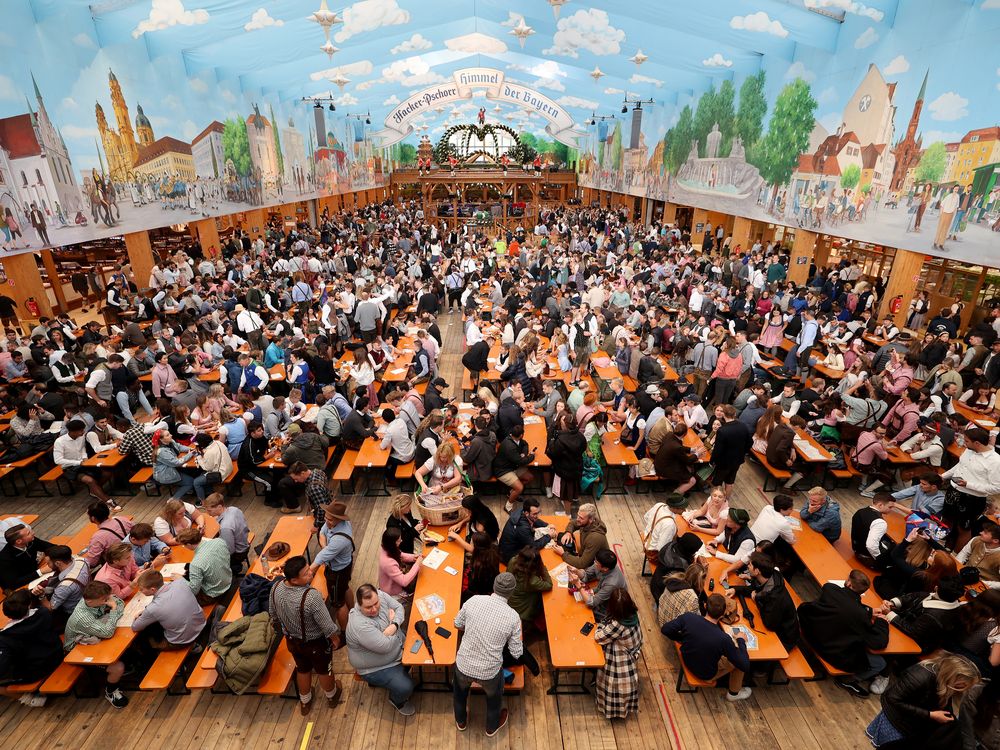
{"left": 577, "top": 0, "right": 1000, "bottom": 266}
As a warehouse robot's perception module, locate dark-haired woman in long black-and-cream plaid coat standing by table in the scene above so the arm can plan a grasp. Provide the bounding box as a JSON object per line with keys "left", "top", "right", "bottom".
{"left": 594, "top": 588, "right": 642, "bottom": 719}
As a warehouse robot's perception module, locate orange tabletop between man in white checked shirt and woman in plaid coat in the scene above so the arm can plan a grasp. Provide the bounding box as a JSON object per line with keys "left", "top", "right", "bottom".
{"left": 541, "top": 516, "right": 604, "bottom": 669}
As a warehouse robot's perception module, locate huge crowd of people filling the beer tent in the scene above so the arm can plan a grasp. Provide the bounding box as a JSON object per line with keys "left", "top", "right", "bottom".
{"left": 0, "top": 202, "right": 1000, "bottom": 750}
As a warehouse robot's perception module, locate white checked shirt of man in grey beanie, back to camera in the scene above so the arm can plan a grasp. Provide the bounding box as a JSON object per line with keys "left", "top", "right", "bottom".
{"left": 455, "top": 594, "right": 524, "bottom": 680}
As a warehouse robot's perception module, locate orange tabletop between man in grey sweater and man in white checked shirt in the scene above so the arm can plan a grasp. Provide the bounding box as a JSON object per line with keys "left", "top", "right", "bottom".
{"left": 403, "top": 526, "right": 465, "bottom": 667}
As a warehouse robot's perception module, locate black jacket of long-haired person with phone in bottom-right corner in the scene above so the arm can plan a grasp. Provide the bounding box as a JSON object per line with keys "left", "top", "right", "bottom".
{"left": 882, "top": 662, "right": 981, "bottom": 750}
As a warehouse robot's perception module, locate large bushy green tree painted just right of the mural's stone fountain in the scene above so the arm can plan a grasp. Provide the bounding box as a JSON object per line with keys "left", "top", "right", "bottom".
{"left": 753, "top": 78, "right": 816, "bottom": 200}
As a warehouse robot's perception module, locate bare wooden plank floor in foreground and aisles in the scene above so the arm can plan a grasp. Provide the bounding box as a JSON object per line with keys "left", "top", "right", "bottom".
{"left": 0, "top": 314, "right": 900, "bottom": 750}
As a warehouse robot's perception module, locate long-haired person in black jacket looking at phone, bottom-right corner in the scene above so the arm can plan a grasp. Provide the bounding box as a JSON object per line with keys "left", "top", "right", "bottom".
{"left": 866, "top": 651, "right": 982, "bottom": 750}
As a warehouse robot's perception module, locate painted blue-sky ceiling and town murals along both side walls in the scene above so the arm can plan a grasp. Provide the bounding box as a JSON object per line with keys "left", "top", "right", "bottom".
{"left": 0, "top": 0, "right": 1000, "bottom": 265}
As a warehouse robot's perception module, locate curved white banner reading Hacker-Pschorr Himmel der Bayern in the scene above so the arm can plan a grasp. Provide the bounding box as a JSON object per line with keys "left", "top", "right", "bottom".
{"left": 373, "top": 68, "right": 586, "bottom": 148}
